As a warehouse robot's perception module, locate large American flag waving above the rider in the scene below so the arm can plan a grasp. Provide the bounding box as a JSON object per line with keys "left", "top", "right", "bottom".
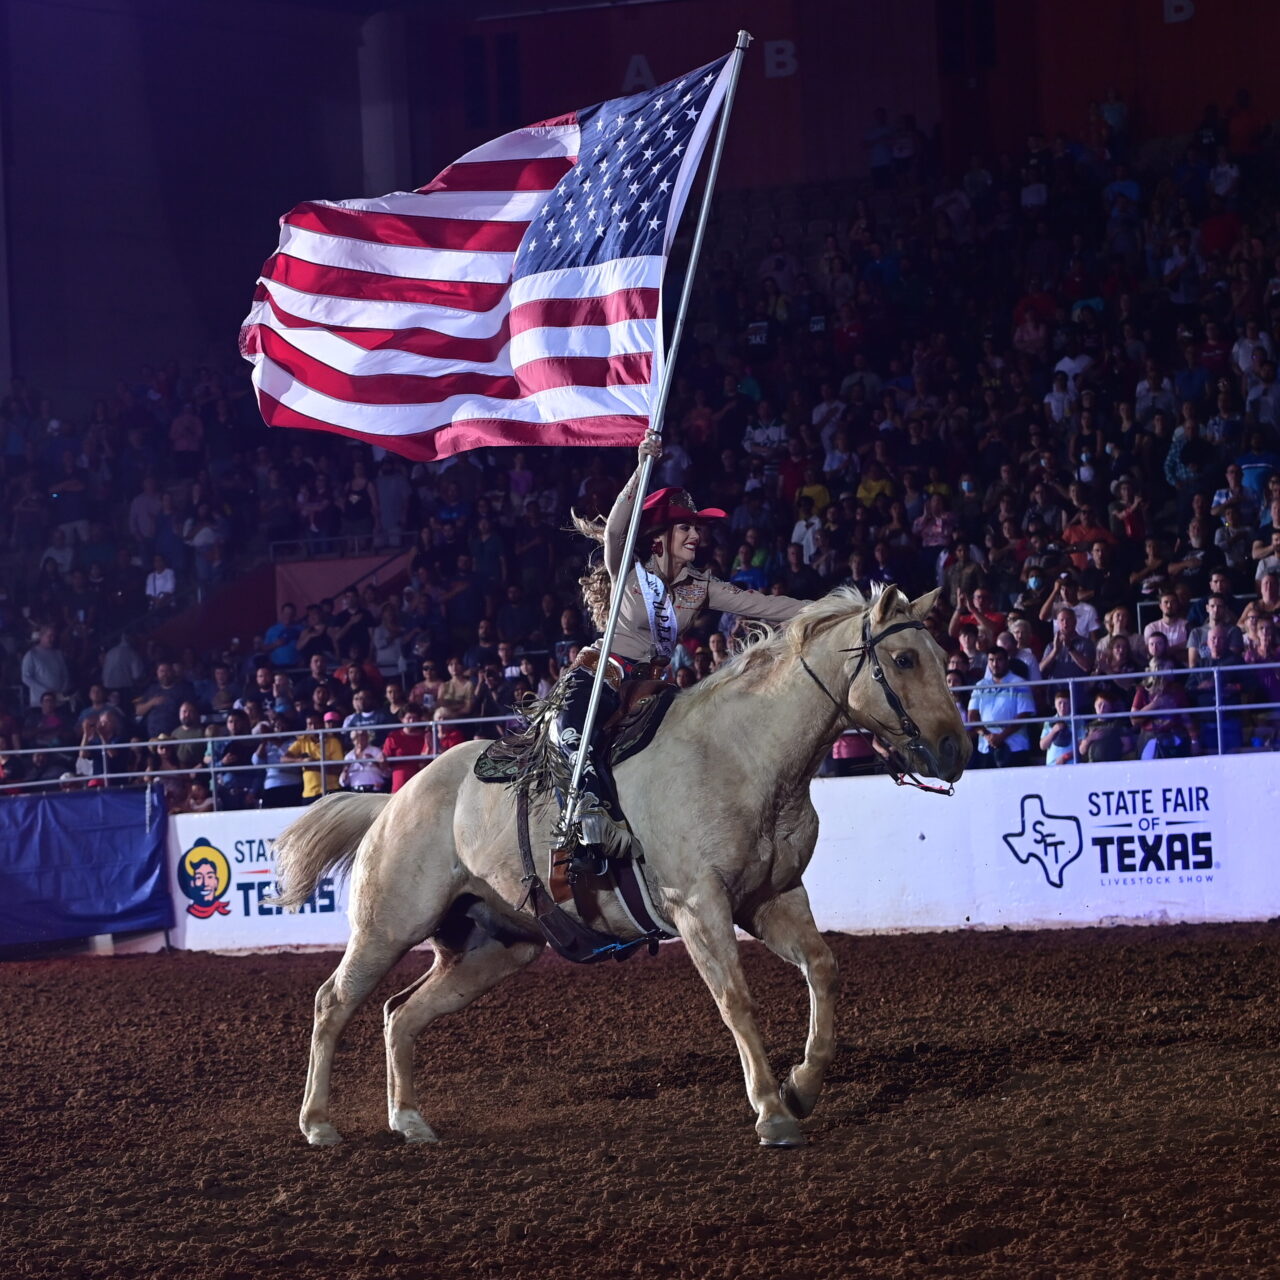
{"left": 241, "top": 56, "right": 731, "bottom": 461}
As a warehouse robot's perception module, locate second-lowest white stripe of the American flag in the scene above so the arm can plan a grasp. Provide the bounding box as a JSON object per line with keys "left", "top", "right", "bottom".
{"left": 251, "top": 319, "right": 657, "bottom": 378}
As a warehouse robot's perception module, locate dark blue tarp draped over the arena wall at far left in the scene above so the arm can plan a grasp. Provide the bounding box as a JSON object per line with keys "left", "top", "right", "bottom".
{"left": 0, "top": 788, "right": 173, "bottom": 945}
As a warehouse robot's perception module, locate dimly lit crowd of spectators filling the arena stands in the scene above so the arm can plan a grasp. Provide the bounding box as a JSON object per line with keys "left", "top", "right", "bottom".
{"left": 0, "top": 92, "right": 1280, "bottom": 808}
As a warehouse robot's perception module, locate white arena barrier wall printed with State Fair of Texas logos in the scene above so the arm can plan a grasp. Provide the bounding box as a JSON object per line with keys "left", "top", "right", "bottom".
{"left": 169, "top": 754, "right": 1280, "bottom": 950}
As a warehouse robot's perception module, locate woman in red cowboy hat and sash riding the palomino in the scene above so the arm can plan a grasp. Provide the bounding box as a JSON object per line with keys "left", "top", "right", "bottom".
{"left": 554, "top": 433, "right": 808, "bottom": 872}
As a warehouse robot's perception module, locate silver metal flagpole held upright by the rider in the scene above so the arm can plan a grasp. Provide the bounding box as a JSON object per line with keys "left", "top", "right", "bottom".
{"left": 564, "top": 31, "right": 751, "bottom": 828}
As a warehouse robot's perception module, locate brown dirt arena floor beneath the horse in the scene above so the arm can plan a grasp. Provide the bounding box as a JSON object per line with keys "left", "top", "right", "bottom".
{"left": 0, "top": 925, "right": 1280, "bottom": 1280}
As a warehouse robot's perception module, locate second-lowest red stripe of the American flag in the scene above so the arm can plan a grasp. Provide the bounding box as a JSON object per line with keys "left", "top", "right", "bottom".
{"left": 256, "top": 325, "right": 653, "bottom": 404}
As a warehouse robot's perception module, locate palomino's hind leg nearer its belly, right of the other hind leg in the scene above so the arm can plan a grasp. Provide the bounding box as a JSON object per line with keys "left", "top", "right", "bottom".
{"left": 383, "top": 916, "right": 543, "bottom": 1142}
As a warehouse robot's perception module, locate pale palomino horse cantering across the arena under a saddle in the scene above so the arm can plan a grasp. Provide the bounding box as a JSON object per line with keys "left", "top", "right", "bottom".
{"left": 275, "top": 588, "right": 970, "bottom": 1147}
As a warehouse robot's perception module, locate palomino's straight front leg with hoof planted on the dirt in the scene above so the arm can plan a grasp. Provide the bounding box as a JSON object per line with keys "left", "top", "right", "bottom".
{"left": 672, "top": 884, "right": 805, "bottom": 1147}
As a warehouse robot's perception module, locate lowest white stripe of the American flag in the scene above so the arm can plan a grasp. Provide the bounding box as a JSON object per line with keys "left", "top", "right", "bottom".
{"left": 253, "top": 356, "right": 650, "bottom": 435}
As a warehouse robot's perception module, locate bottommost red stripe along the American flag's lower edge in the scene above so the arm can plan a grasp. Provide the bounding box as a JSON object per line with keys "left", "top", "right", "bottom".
{"left": 257, "top": 392, "right": 649, "bottom": 462}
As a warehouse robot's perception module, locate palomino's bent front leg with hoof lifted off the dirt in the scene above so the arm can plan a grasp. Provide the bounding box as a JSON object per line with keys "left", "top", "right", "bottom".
{"left": 751, "top": 884, "right": 837, "bottom": 1117}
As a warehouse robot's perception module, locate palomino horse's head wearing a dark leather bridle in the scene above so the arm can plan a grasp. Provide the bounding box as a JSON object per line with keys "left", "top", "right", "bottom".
{"left": 847, "top": 586, "right": 973, "bottom": 782}
